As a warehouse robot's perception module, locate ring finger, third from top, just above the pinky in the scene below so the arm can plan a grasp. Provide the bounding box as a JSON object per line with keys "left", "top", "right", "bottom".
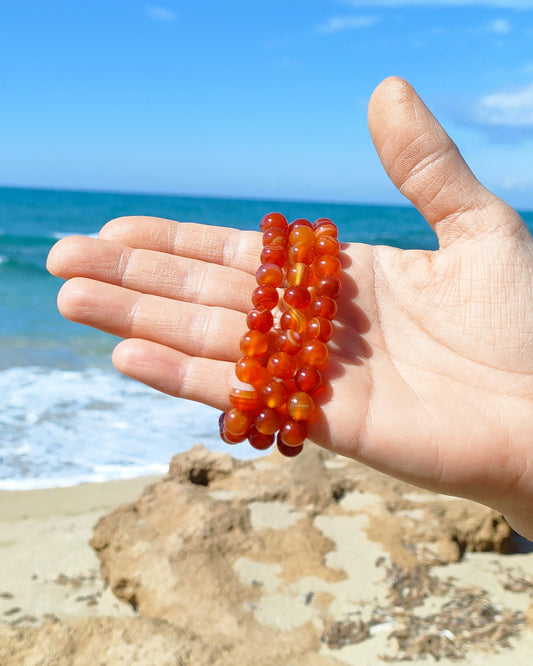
{"left": 58, "top": 278, "right": 241, "bottom": 362}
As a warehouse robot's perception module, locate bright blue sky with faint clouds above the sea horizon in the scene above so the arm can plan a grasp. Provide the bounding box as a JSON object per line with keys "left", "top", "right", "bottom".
{"left": 0, "top": 0, "right": 533, "bottom": 210}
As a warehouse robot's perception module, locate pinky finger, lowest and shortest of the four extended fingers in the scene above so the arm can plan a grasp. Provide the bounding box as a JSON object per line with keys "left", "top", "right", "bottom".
{"left": 113, "top": 338, "right": 235, "bottom": 410}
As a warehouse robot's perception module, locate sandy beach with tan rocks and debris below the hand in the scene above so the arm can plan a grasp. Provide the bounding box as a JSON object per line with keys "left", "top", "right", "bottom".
{"left": 0, "top": 446, "right": 533, "bottom": 666}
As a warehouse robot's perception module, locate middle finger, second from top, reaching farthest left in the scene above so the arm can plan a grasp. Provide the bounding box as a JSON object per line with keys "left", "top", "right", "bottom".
{"left": 47, "top": 236, "right": 256, "bottom": 312}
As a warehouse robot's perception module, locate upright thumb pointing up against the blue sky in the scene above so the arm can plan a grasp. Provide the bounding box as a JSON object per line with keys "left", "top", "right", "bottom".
{"left": 368, "top": 77, "right": 522, "bottom": 247}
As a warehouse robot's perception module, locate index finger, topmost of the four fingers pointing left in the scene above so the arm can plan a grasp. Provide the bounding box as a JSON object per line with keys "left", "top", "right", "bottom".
{"left": 100, "top": 217, "right": 261, "bottom": 273}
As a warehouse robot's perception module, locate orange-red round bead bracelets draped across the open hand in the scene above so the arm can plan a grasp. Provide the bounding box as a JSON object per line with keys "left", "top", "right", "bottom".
{"left": 219, "top": 213, "right": 342, "bottom": 457}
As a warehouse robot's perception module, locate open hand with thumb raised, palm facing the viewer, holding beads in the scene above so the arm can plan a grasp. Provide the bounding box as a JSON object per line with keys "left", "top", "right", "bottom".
{"left": 44, "top": 78, "right": 533, "bottom": 537}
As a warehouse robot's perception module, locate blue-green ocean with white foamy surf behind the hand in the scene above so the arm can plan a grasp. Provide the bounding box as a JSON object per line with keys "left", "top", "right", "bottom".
{"left": 0, "top": 188, "right": 533, "bottom": 490}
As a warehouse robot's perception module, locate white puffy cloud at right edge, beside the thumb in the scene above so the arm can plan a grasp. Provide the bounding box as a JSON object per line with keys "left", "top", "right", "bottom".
{"left": 476, "top": 83, "right": 533, "bottom": 130}
